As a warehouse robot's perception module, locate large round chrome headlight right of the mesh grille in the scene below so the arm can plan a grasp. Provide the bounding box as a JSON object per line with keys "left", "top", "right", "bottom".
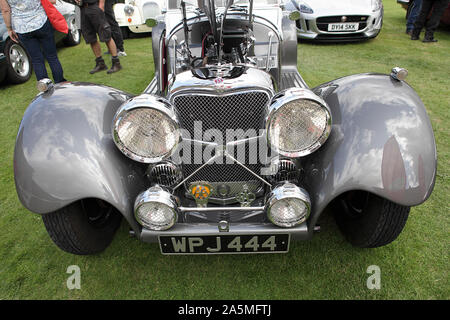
{"left": 266, "top": 88, "right": 331, "bottom": 158}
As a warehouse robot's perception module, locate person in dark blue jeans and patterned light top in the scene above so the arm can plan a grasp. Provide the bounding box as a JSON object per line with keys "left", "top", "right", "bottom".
{"left": 0, "top": 0, "right": 67, "bottom": 83}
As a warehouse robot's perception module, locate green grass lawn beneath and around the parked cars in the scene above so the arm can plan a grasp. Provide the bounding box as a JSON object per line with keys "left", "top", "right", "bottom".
{"left": 0, "top": 0, "right": 450, "bottom": 299}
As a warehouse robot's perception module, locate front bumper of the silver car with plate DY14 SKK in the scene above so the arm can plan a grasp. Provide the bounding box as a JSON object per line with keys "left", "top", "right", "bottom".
{"left": 296, "top": 9, "right": 383, "bottom": 41}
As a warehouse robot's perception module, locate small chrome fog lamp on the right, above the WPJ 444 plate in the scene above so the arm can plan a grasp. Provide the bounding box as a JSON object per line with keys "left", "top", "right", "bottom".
{"left": 266, "top": 183, "right": 311, "bottom": 228}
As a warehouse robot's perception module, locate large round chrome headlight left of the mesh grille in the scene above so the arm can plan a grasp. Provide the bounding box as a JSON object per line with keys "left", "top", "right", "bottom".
{"left": 113, "top": 94, "right": 181, "bottom": 163}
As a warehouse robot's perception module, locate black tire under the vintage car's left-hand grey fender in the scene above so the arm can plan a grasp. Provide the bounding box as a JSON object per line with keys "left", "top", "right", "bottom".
{"left": 42, "top": 199, "right": 122, "bottom": 255}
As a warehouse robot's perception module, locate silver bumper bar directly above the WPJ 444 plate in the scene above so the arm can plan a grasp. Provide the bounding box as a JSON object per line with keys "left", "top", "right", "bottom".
{"left": 140, "top": 223, "right": 312, "bottom": 243}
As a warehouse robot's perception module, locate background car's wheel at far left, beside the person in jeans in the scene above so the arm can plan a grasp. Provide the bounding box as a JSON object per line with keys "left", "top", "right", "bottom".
{"left": 4, "top": 38, "right": 33, "bottom": 84}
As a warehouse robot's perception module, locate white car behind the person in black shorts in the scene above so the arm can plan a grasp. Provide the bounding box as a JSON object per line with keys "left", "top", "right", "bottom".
{"left": 113, "top": 0, "right": 165, "bottom": 38}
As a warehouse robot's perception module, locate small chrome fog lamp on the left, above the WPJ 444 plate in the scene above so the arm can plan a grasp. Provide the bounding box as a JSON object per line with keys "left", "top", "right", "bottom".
{"left": 134, "top": 186, "right": 178, "bottom": 231}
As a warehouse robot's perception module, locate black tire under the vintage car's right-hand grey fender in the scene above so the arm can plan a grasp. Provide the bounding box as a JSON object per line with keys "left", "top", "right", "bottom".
{"left": 334, "top": 191, "right": 410, "bottom": 248}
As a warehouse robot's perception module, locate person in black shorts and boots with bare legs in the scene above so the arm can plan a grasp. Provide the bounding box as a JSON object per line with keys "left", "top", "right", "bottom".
{"left": 81, "top": 0, "right": 122, "bottom": 74}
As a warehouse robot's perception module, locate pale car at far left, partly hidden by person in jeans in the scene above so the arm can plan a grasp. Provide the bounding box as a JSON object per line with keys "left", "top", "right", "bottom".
{"left": 0, "top": 0, "right": 81, "bottom": 83}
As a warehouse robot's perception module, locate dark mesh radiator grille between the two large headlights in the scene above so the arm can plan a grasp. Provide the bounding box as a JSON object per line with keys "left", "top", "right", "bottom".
{"left": 173, "top": 91, "right": 270, "bottom": 198}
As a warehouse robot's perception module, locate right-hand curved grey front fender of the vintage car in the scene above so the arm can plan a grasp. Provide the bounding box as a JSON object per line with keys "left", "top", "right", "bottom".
{"left": 305, "top": 74, "right": 437, "bottom": 229}
